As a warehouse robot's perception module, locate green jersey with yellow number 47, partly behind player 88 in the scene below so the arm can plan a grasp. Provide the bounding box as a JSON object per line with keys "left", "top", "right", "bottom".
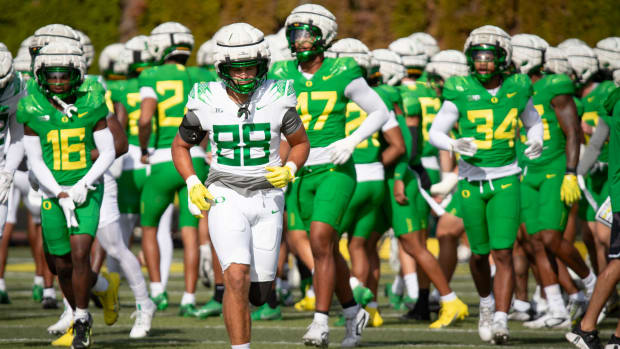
{"left": 269, "top": 57, "right": 362, "bottom": 148}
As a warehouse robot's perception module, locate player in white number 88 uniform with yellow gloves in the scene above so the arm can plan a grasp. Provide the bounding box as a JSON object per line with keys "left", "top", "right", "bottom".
{"left": 172, "top": 23, "right": 310, "bottom": 348}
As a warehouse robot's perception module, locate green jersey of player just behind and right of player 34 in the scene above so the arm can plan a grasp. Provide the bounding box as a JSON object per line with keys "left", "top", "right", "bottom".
{"left": 517, "top": 74, "right": 575, "bottom": 167}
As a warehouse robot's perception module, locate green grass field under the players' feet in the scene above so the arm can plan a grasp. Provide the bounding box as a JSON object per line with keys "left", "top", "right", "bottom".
{"left": 0, "top": 247, "right": 616, "bottom": 349}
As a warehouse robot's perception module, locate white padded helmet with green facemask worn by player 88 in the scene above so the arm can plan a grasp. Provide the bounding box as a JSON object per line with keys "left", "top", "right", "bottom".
{"left": 213, "top": 23, "right": 269, "bottom": 93}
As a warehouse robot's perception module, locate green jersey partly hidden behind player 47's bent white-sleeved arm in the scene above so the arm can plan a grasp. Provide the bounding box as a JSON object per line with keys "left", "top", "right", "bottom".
{"left": 346, "top": 87, "right": 394, "bottom": 164}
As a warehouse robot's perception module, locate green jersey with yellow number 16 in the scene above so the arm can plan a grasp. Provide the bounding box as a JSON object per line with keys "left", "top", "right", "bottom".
{"left": 17, "top": 84, "right": 109, "bottom": 186}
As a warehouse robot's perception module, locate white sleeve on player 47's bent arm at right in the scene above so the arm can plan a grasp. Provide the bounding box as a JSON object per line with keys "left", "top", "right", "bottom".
{"left": 344, "top": 77, "right": 388, "bottom": 142}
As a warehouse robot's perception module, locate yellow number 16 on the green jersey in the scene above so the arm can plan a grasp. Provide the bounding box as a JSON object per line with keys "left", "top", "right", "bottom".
{"left": 47, "top": 127, "right": 86, "bottom": 171}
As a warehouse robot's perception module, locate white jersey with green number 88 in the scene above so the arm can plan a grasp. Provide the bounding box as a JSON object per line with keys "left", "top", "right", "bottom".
{"left": 187, "top": 80, "right": 301, "bottom": 177}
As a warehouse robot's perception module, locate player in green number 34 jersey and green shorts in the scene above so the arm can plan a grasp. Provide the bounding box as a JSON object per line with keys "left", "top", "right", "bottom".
{"left": 430, "top": 25, "right": 543, "bottom": 343}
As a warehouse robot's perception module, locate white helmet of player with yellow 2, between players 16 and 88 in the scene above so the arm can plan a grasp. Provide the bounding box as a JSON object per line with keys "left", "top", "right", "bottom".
{"left": 149, "top": 22, "right": 194, "bottom": 62}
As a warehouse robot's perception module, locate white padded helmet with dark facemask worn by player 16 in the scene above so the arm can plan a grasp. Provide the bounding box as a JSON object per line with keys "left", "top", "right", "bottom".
{"left": 34, "top": 42, "right": 86, "bottom": 98}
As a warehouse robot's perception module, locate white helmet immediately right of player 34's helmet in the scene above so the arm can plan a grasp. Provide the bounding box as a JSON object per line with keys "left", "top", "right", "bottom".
{"left": 511, "top": 34, "right": 549, "bottom": 74}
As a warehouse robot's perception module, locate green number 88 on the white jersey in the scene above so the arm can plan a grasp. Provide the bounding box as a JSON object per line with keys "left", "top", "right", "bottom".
{"left": 213, "top": 123, "right": 271, "bottom": 166}
